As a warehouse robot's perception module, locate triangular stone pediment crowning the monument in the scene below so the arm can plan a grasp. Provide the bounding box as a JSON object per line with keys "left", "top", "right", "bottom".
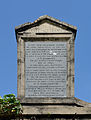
{"left": 15, "top": 15, "right": 77, "bottom": 35}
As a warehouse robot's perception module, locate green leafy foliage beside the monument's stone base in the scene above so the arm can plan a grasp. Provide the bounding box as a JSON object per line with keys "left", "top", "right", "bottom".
{"left": 0, "top": 94, "right": 22, "bottom": 115}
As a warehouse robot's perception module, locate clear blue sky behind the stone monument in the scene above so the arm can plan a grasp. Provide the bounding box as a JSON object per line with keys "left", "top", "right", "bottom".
{"left": 0, "top": 0, "right": 91, "bottom": 102}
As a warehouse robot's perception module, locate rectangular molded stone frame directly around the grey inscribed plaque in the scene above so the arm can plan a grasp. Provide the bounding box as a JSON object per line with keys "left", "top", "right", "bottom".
{"left": 17, "top": 33, "right": 75, "bottom": 103}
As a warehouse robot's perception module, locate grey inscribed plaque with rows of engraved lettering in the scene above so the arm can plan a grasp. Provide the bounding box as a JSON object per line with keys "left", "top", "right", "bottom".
{"left": 25, "top": 41, "right": 67, "bottom": 98}
